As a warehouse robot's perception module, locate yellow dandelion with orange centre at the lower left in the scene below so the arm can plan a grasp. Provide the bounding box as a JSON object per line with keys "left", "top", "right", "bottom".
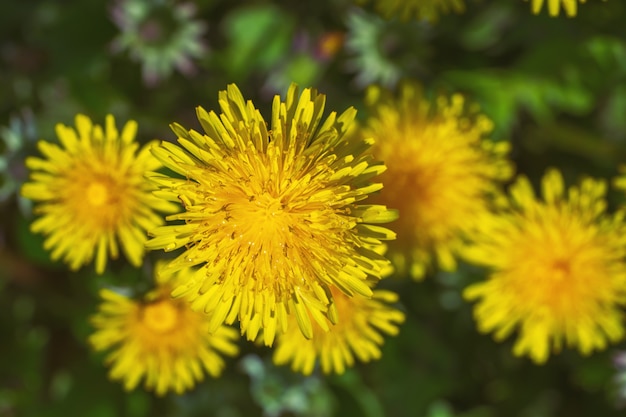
{"left": 89, "top": 264, "right": 239, "bottom": 395}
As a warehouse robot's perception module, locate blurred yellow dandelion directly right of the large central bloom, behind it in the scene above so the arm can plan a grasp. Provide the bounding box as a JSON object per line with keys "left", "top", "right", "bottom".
{"left": 362, "top": 84, "right": 513, "bottom": 279}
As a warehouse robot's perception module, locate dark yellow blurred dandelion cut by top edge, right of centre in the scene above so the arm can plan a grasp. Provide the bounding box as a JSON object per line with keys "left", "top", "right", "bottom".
{"left": 358, "top": 0, "right": 465, "bottom": 22}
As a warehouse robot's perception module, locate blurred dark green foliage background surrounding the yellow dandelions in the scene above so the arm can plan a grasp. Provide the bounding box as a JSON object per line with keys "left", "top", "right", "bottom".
{"left": 0, "top": 0, "right": 626, "bottom": 417}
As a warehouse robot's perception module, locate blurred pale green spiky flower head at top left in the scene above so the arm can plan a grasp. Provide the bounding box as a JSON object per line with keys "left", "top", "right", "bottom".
{"left": 111, "top": 0, "right": 207, "bottom": 85}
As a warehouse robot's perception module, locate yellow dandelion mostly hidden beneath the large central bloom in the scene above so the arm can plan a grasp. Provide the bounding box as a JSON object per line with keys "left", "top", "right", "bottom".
{"left": 273, "top": 284, "right": 404, "bottom": 375}
